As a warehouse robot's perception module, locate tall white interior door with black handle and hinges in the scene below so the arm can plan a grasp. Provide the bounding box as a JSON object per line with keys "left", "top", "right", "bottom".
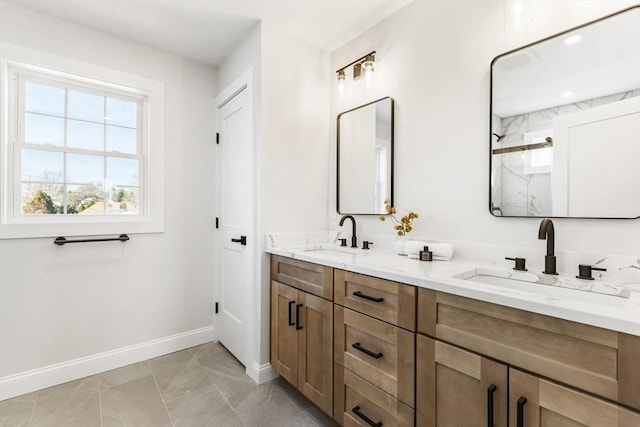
{"left": 216, "top": 84, "right": 256, "bottom": 367}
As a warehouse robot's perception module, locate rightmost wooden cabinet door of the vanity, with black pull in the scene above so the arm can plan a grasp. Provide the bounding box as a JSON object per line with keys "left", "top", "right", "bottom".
{"left": 509, "top": 369, "right": 640, "bottom": 427}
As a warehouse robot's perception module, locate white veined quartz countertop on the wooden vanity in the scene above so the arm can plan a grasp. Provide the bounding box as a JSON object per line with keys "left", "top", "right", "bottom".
{"left": 267, "top": 244, "right": 640, "bottom": 336}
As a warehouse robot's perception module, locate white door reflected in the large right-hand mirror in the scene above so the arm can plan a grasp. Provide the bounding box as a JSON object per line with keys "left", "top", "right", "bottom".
{"left": 551, "top": 97, "right": 640, "bottom": 218}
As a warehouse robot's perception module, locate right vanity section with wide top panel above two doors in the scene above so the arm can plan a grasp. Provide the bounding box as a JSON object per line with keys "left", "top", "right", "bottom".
{"left": 416, "top": 289, "right": 640, "bottom": 427}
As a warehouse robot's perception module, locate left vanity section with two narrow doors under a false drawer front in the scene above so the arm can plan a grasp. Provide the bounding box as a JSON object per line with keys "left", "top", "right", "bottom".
{"left": 271, "top": 256, "right": 333, "bottom": 415}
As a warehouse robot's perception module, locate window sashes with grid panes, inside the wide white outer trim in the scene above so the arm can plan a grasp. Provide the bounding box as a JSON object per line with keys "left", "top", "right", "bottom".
{"left": 13, "top": 71, "right": 145, "bottom": 216}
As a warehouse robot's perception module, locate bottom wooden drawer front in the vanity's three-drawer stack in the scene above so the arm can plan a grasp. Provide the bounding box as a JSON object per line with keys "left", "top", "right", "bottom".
{"left": 333, "top": 364, "right": 415, "bottom": 427}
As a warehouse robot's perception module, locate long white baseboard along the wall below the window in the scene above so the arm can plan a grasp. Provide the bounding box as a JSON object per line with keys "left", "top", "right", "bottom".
{"left": 0, "top": 326, "right": 215, "bottom": 400}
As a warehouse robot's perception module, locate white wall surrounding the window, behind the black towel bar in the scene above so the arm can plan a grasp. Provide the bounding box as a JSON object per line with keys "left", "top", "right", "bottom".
{"left": 0, "top": 2, "right": 217, "bottom": 399}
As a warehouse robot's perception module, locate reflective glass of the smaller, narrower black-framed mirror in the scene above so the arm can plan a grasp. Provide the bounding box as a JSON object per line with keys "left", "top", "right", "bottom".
{"left": 337, "top": 97, "right": 393, "bottom": 215}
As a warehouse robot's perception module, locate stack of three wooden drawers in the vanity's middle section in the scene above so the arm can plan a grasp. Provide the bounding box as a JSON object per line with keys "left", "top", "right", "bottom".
{"left": 334, "top": 270, "right": 416, "bottom": 427}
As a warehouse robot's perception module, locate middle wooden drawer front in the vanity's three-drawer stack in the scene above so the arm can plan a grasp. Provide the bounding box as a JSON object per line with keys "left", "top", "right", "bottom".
{"left": 334, "top": 305, "right": 415, "bottom": 407}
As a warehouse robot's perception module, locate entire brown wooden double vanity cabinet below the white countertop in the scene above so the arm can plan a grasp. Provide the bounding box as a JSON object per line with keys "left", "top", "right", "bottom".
{"left": 271, "top": 255, "right": 640, "bottom": 427}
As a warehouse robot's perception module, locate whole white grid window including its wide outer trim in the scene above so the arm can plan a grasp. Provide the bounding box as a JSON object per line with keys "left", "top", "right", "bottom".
{"left": 0, "top": 46, "right": 166, "bottom": 239}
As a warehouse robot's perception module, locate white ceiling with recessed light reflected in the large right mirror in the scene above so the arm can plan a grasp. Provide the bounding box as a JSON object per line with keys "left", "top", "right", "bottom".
{"left": 492, "top": 9, "right": 640, "bottom": 118}
